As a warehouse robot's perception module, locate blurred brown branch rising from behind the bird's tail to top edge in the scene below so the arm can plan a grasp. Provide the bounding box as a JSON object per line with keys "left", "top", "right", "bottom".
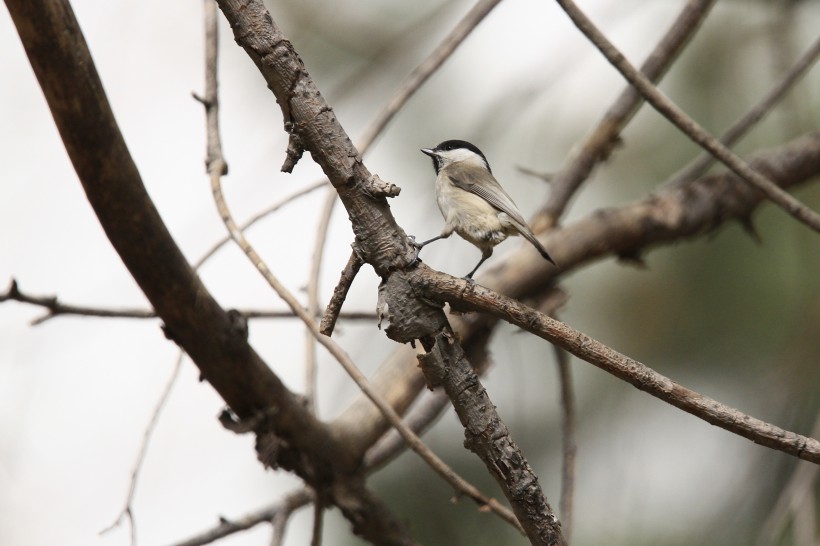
{"left": 534, "top": 0, "right": 715, "bottom": 227}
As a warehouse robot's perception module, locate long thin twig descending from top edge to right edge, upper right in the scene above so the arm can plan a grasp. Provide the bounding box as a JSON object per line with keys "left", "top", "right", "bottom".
{"left": 556, "top": 0, "right": 820, "bottom": 232}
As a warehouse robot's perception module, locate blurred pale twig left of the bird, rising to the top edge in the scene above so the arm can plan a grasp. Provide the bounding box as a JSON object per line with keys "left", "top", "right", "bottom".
{"left": 358, "top": 0, "right": 501, "bottom": 155}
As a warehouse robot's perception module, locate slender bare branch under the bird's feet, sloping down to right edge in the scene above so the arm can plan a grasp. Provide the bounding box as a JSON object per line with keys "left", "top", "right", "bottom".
{"left": 410, "top": 266, "right": 820, "bottom": 463}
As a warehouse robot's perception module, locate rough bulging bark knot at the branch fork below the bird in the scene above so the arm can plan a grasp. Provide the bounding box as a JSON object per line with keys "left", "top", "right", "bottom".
{"left": 376, "top": 271, "right": 447, "bottom": 343}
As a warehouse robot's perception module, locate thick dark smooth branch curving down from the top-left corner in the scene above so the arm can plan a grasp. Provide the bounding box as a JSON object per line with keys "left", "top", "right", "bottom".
{"left": 6, "top": 0, "right": 342, "bottom": 468}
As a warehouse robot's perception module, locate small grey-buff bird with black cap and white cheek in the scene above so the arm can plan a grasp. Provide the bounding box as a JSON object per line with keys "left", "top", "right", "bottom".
{"left": 413, "top": 140, "right": 555, "bottom": 281}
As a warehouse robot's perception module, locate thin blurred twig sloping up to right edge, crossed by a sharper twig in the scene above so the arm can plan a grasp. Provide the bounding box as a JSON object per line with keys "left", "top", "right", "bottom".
{"left": 664, "top": 34, "right": 820, "bottom": 187}
